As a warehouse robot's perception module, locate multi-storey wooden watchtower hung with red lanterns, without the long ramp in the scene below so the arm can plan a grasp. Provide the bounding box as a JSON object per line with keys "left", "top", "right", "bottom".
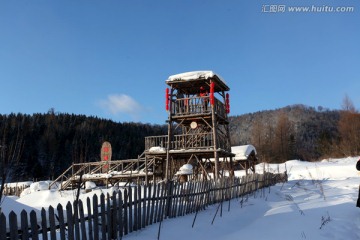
{"left": 145, "top": 71, "right": 235, "bottom": 179}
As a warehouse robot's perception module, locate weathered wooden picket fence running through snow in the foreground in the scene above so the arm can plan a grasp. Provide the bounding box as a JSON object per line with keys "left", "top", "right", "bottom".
{"left": 0, "top": 173, "right": 287, "bottom": 240}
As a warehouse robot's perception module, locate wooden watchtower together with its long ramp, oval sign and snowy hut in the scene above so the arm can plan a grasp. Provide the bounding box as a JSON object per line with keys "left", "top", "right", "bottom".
{"left": 50, "top": 71, "right": 240, "bottom": 190}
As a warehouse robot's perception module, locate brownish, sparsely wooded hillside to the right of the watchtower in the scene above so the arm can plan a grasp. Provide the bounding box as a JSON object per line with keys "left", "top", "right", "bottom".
{"left": 230, "top": 102, "right": 360, "bottom": 162}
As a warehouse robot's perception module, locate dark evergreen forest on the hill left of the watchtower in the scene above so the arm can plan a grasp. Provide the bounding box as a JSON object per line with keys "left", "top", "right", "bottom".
{"left": 0, "top": 111, "right": 167, "bottom": 181}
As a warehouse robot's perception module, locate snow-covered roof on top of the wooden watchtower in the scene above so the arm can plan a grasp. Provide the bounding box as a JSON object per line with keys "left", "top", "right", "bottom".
{"left": 166, "top": 71, "right": 230, "bottom": 94}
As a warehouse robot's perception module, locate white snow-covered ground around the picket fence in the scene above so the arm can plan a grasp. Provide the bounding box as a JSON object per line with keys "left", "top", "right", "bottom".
{"left": 1, "top": 157, "right": 360, "bottom": 240}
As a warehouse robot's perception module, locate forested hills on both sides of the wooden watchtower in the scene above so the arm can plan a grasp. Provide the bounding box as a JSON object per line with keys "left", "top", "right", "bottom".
{"left": 0, "top": 97, "right": 360, "bottom": 181}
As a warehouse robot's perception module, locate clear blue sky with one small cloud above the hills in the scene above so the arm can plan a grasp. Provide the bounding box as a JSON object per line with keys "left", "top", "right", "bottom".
{"left": 0, "top": 0, "right": 360, "bottom": 124}
